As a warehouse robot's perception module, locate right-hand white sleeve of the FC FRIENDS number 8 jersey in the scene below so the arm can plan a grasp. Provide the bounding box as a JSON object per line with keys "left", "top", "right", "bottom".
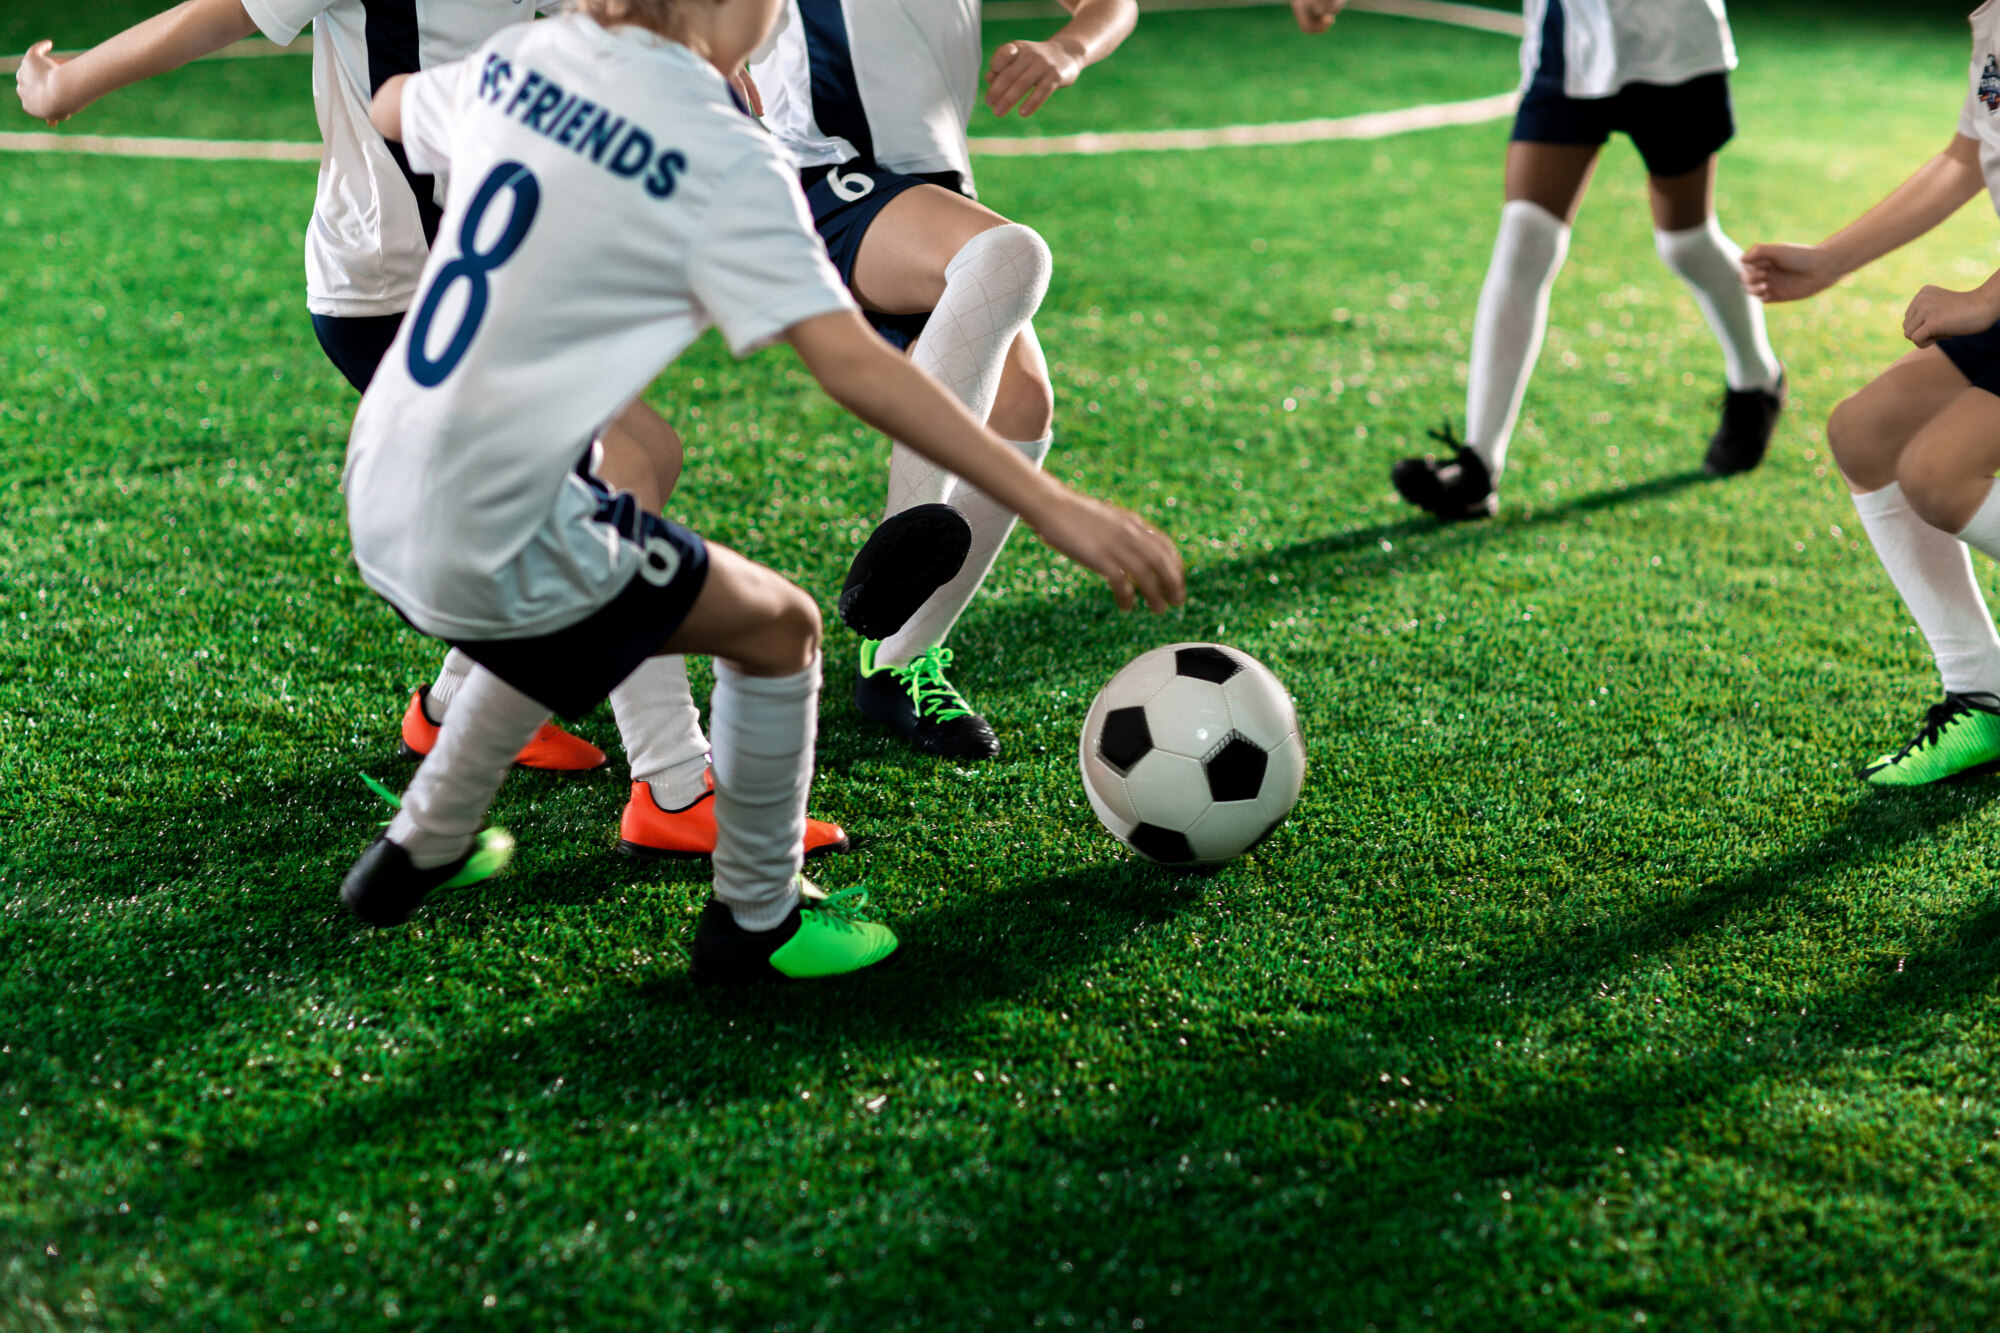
{"left": 688, "top": 144, "right": 856, "bottom": 356}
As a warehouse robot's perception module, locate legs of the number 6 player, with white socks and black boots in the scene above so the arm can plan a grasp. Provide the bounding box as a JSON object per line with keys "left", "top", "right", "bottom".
{"left": 850, "top": 186, "right": 1054, "bottom": 759}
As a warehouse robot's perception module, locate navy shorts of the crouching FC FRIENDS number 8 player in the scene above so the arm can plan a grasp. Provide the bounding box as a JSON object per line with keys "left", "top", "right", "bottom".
{"left": 452, "top": 482, "right": 708, "bottom": 719}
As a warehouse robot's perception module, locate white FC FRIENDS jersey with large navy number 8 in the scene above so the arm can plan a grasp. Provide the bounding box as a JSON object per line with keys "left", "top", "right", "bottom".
{"left": 344, "top": 18, "right": 854, "bottom": 640}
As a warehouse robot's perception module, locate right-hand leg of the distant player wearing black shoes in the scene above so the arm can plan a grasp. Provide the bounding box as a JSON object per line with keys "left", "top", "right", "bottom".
{"left": 1648, "top": 156, "right": 1784, "bottom": 476}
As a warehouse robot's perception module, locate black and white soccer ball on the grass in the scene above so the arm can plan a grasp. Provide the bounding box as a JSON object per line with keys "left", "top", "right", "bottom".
{"left": 1076, "top": 642, "right": 1306, "bottom": 865}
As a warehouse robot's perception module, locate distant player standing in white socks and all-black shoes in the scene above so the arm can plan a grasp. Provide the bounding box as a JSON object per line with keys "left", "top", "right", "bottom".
{"left": 1292, "top": 0, "right": 1784, "bottom": 520}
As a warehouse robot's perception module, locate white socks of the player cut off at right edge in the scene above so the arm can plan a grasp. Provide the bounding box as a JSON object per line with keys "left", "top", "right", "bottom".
{"left": 1854, "top": 482, "right": 2000, "bottom": 695}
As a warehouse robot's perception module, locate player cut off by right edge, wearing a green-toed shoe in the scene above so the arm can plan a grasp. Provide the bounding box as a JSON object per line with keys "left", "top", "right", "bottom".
{"left": 1744, "top": 4, "right": 2000, "bottom": 787}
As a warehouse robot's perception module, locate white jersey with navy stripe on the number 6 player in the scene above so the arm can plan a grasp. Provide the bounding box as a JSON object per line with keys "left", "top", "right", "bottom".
{"left": 750, "top": 0, "right": 980, "bottom": 190}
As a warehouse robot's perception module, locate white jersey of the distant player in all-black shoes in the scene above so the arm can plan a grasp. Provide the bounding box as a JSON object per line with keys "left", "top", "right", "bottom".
{"left": 1520, "top": 0, "right": 1736, "bottom": 98}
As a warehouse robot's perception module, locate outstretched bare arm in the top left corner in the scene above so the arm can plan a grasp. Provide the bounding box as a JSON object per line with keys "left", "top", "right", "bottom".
{"left": 14, "top": 0, "right": 256, "bottom": 124}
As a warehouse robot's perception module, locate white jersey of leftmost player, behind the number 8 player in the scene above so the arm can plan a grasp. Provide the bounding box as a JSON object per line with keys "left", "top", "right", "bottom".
{"left": 244, "top": 0, "right": 552, "bottom": 314}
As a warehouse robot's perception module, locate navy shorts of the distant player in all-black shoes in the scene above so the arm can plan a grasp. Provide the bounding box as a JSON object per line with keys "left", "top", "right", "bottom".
{"left": 1514, "top": 0, "right": 1736, "bottom": 176}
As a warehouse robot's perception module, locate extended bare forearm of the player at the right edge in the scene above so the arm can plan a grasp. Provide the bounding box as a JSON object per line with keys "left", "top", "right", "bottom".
{"left": 1744, "top": 134, "right": 1992, "bottom": 304}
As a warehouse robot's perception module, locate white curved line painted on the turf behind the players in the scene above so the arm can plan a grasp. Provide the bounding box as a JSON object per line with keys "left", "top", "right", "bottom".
{"left": 0, "top": 0, "right": 1522, "bottom": 162}
